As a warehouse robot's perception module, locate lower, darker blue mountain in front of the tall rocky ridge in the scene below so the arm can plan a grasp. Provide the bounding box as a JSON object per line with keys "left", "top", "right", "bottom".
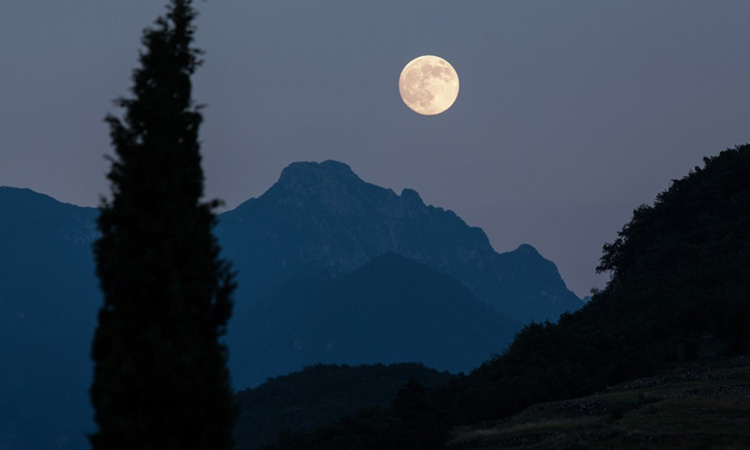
{"left": 229, "top": 253, "right": 521, "bottom": 385}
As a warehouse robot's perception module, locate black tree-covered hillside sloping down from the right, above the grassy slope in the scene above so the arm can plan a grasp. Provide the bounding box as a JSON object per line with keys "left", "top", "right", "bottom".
{"left": 264, "top": 145, "right": 750, "bottom": 449}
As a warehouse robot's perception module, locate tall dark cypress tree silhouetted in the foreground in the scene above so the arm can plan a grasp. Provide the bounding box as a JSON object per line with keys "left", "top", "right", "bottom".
{"left": 89, "top": 0, "right": 236, "bottom": 450}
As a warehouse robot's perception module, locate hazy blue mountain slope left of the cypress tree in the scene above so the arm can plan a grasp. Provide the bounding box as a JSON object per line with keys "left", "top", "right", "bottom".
{"left": 0, "top": 187, "right": 100, "bottom": 449}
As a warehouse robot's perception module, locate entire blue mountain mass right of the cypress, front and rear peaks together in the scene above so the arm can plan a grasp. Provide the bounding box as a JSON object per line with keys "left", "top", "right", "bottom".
{"left": 216, "top": 161, "right": 583, "bottom": 386}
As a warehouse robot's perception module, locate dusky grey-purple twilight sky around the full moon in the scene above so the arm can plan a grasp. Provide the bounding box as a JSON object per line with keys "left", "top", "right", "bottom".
{"left": 0, "top": 0, "right": 750, "bottom": 296}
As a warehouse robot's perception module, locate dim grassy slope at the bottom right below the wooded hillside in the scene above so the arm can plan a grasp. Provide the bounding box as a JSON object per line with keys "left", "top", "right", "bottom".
{"left": 449, "top": 358, "right": 750, "bottom": 450}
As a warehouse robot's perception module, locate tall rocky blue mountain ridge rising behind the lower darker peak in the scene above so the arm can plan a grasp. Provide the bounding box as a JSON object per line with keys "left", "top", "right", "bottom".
{"left": 217, "top": 161, "right": 583, "bottom": 323}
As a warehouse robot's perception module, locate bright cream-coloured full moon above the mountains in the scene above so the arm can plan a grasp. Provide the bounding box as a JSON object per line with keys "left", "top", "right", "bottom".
{"left": 398, "top": 55, "right": 458, "bottom": 116}
